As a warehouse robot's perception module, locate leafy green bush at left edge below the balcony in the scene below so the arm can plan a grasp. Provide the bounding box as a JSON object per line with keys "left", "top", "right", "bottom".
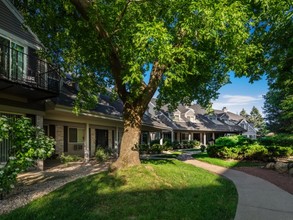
{"left": 0, "top": 116, "right": 55, "bottom": 197}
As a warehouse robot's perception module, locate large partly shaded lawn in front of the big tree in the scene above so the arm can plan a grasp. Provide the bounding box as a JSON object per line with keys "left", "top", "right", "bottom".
{"left": 0, "top": 160, "right": 237, "bottom": 220}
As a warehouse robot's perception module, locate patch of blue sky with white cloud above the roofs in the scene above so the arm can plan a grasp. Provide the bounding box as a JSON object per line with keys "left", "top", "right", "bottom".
{"left": 213, "top": 74, "right": 268, "bottom": 114}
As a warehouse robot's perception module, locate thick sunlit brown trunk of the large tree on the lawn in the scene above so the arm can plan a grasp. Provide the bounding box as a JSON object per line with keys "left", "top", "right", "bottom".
{"left": 111, "top": 104, "right": 144, "bottom": 170}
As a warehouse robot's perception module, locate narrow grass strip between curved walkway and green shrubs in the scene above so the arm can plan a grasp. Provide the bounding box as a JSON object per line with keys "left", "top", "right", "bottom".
{"left": 192, "top": 153, "right": 264, "bottom": 168}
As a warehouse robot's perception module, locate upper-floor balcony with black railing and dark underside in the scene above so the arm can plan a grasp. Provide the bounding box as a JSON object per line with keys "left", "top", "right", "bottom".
{"left": 0, "top": 41, "right": 60, "bottom": 101}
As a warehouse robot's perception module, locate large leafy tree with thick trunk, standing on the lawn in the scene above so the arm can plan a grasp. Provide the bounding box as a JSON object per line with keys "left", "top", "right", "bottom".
{"left": 19, "top": 0, "right": 290, "bottom": 167}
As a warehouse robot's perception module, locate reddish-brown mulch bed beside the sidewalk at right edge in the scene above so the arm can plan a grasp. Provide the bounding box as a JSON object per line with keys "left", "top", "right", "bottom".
{"left": 234, "top": 167, "right": 293, "bottom": 194}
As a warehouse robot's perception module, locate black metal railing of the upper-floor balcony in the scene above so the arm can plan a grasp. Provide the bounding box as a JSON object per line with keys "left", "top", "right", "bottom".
{"left": 0, "top": 43, "right": 60, "bottom": 94}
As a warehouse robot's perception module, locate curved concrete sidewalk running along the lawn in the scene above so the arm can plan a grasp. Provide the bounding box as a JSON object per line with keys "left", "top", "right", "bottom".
{"left": 184, "top": 158, "right": 293, "bottom": 220}
